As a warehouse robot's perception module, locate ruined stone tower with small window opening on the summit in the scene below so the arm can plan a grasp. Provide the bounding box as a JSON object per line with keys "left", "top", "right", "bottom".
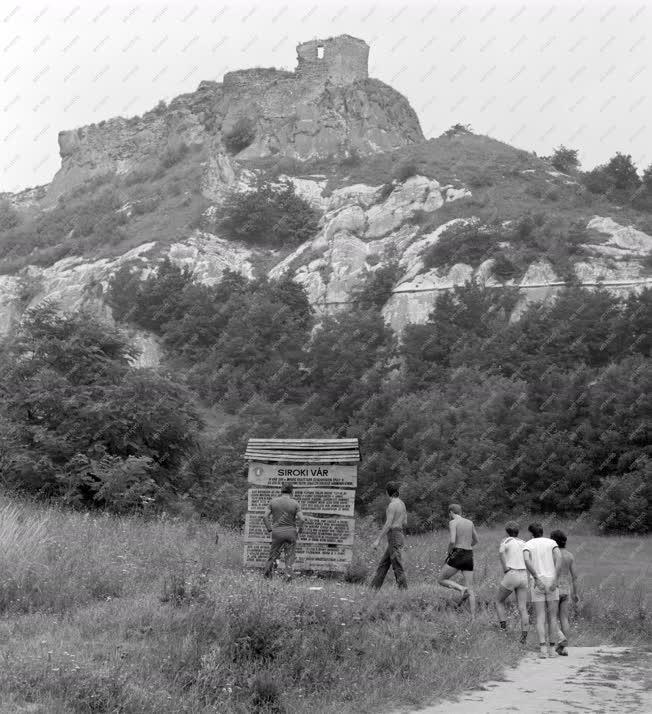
{"left": 296, "top": 35, "right": 369, "bottom": 85}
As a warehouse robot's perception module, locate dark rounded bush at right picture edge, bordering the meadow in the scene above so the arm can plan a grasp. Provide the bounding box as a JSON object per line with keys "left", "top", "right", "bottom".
{"left": 591, "top": 457, "right": 652, "bottom": 535}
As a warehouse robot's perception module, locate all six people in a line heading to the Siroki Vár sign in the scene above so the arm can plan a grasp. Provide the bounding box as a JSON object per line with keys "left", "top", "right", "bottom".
{"left": 263, "top": 482, "right": 579, "bottom": 658}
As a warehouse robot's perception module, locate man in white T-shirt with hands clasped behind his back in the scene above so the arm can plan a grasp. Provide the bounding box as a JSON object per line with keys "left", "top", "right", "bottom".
{"left": 523, "top": 523, "right": 561, "bottom": 658}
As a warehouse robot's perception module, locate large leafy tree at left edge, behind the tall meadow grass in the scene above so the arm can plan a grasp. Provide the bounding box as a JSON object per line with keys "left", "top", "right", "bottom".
{"left": 0, "top": 304, "right": 201, "bottom": 510}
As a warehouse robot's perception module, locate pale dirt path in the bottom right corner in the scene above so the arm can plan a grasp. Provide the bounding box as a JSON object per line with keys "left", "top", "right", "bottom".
{"left": 415, "top": 646, "right": 652, "bottom": 714}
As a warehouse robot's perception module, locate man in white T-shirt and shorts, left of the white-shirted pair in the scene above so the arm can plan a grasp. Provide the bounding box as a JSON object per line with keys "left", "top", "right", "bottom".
{"left": 496, "top": 521, "right": 530, "bottom": 644}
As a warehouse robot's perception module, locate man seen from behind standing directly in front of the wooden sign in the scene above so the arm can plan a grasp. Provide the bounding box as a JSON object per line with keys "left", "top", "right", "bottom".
{"left": 263, "top": 482, "right": 304, "bottom": 579}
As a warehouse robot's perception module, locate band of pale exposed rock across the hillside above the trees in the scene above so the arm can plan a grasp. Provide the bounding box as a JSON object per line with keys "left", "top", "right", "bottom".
{"left": 0, "top": 170, "right": 652, "bottom": 366}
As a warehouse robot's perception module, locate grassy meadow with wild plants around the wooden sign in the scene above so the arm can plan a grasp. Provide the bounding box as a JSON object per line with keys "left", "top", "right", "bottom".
{"left": 0, "top": 499, "right": 652, "bottom": 714}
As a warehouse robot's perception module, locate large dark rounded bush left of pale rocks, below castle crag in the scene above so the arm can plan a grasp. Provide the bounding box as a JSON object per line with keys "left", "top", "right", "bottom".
{"left": 217, "top": 180, "right": 318, "bottom": 247}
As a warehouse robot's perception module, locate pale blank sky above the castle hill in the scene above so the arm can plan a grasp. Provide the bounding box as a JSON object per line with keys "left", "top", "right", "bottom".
{"left": 0, "top": 0, "right": 652, "bottom": 191}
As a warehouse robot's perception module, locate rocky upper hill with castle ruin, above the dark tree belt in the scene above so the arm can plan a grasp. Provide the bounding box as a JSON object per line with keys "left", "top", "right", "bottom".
{"left": 0, "top": 35, "right": 652, "bottom": 364}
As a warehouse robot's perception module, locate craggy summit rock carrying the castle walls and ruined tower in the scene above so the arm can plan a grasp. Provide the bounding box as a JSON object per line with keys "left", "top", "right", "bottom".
{"left": 49, "top": 35, "right": 424, "bottom": 200}
